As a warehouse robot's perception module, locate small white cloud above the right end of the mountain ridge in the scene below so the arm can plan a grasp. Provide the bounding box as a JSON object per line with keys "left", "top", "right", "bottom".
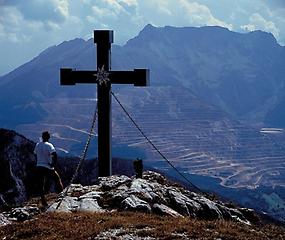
{"left": 241, "top": 13, "right": 280, "bottom": 38}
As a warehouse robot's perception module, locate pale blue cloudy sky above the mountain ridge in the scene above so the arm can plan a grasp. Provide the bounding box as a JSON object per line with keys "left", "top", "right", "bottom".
{"left": 0, "top": 0, "right": 285, "bottom": 75}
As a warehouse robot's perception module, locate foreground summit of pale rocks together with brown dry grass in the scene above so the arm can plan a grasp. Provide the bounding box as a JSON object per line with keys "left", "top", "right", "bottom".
{"left": 0, "top": 171, "right": 285, "bottom": 240}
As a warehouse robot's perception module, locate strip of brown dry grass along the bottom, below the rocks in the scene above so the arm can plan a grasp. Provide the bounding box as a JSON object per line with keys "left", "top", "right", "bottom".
{"left": 0, "top": 212, "right": 285, "bottom": 240}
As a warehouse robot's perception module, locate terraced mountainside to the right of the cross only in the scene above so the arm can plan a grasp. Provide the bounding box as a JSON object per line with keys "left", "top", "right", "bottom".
{"left": 114, "top": 88, "right": 285, "bottom": 188}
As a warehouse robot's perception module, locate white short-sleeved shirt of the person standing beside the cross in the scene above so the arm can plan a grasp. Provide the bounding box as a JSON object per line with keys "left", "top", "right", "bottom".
{"left": 34, "top": 142, "right": 56, "bottom": 169}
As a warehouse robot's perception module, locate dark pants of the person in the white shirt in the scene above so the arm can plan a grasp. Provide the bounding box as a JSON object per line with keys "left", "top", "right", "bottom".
{"left": 37, "top": 167, "right": 63, "bottom": 206}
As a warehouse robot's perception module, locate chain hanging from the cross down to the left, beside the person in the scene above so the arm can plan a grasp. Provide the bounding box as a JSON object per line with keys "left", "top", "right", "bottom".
{"left": 55, "top": 101, "right": 98, "bottom": 210}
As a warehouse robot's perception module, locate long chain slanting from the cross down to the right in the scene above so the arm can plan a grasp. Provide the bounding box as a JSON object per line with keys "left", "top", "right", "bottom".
{"left": 111, "top": 91, "right": 203, "bottom": 194}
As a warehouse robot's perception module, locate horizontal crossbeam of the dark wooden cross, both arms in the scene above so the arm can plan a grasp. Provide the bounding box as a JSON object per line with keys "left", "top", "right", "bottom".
{"left": 60, "top": 68, "right": 149, "bottom": 86}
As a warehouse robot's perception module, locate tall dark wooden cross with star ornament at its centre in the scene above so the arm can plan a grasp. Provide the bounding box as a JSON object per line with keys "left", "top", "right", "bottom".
{"left": 60, "top": 30, "right": 149, "bottom": 177}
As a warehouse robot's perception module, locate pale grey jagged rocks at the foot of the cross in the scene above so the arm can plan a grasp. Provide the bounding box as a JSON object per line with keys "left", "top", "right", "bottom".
{"left": 43, "top": 171, "right": 257, "bottom": 224}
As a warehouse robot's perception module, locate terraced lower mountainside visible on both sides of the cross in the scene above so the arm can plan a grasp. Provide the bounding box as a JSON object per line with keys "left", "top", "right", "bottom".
{"left": 17, "top": 87, "right": 285, "bottom": 188}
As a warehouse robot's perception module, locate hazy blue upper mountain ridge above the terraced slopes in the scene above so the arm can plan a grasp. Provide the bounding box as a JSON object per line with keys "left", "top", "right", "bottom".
{"left": 0, "top": 25, "right": 285, "bottom": 127}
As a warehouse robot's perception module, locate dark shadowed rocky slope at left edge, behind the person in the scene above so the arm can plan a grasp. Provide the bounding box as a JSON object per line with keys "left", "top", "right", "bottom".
{"left": 0, "top": 128, "right": 35, "bottom": 208}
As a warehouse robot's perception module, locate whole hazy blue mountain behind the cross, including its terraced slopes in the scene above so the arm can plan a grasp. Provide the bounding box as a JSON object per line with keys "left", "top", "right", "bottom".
{"left": 0, "top": 25, "right": 285, "bottom": 221}
